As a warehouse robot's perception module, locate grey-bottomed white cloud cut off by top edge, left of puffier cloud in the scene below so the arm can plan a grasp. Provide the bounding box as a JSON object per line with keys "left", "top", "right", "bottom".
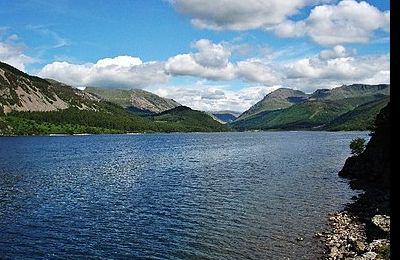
{"left": 169, "top": 0, "right": 321, "bottom": 31}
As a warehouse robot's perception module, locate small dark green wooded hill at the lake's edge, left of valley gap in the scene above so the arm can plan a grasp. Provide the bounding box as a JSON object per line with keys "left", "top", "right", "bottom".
{"left": 149, "top": 106, "right": 230, "bottom": 132}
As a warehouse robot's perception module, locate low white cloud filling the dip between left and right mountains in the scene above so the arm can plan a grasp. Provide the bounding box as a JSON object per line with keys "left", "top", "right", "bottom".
{"left": 149, "top": 83, "right": 279, "bottom": 112}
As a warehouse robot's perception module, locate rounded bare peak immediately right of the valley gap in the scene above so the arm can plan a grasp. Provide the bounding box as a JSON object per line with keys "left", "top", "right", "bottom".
{"left": 237, "top": 88, "right": 308, "bottom": 120}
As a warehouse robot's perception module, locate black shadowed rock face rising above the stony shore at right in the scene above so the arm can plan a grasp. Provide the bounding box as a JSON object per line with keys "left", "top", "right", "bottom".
{"left": 339, "top": 102, "right": 390, "bottom": 190}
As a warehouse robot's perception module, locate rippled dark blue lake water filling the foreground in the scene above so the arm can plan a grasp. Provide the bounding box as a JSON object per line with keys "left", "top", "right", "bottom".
{"left": 0, "top": 132, "right": 368, "bottom": 259}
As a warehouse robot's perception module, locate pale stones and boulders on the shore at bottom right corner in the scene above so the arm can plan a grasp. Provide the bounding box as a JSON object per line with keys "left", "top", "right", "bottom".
{"left": 319, "top": 189, "right": 390, "bottom": 260}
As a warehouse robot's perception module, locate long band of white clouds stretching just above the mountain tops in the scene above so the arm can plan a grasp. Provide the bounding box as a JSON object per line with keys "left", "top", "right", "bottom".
{"left": 33, "top": 39, "right": 390, "bottom": 106}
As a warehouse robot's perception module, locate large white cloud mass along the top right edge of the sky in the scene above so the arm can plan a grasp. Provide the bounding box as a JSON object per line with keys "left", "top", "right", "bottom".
{"left": 169, "top": 0, "right": 390, "bottom": 45}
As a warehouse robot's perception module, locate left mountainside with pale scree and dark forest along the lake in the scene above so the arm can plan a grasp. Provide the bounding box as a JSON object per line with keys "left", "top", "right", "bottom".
{"left": 0, "top": 63, "right": 228, "bottom": 135}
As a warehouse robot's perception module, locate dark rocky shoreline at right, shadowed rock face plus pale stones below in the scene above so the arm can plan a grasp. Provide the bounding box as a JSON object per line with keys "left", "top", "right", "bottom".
{"left": 316, "top": 103, "right": 391, "bottom": 260}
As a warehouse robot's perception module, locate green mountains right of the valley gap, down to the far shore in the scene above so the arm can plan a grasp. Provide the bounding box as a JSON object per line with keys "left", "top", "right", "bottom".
{"left": 230, "top": 84, "right": 390, "bottom": 131}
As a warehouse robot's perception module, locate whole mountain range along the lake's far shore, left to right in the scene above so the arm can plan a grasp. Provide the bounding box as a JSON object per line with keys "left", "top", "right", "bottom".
{"left": 0, "top": 62, "right": 390, "bottom": 135}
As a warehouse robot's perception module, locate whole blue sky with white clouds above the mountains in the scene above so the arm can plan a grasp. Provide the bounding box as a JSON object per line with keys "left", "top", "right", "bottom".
{"left": 0, "top": 0, "right": 390, "bottom": 112}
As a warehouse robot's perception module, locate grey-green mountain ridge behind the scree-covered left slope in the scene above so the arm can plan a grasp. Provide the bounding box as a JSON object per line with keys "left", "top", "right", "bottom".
{"left": 85, "top": 87, "right": 180, "bottom": 115}
